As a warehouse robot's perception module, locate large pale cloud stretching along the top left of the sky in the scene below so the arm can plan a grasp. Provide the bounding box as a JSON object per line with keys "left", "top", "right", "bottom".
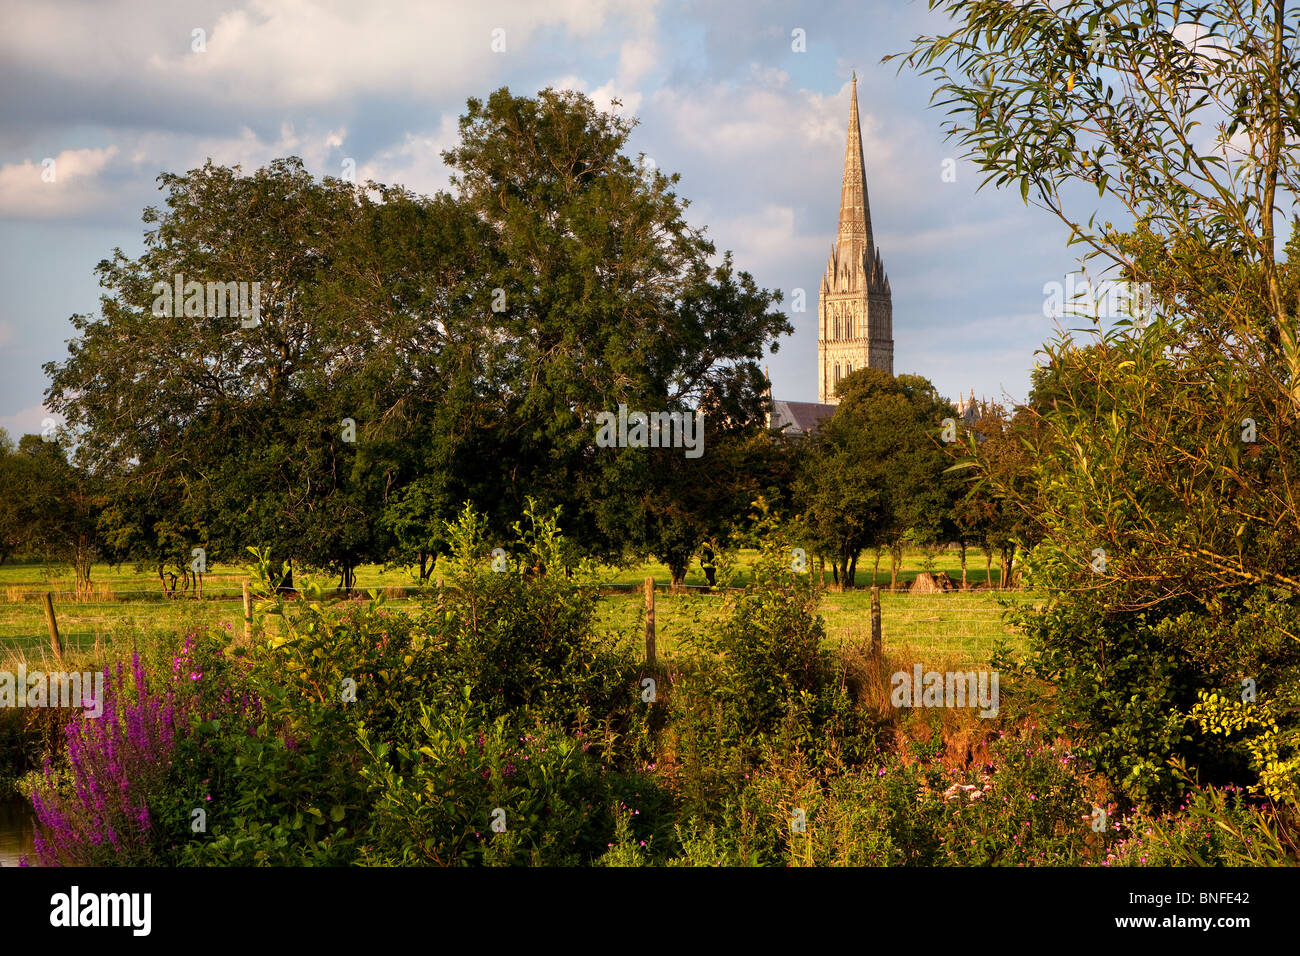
{"left": 0, "top": 0, "right": 631, "bottom": 107}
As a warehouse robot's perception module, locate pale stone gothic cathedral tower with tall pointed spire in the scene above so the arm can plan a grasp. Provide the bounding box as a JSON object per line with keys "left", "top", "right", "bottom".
{"left": 816, "top": 74, "right": 893, "bottom": 405}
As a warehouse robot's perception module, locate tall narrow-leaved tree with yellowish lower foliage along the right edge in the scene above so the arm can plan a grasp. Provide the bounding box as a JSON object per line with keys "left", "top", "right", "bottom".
{"left": 904, "top": 0, "right": 1300, "bottom": 796}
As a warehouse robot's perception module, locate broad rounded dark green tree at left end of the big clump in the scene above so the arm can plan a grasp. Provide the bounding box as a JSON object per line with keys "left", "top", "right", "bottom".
{"left": 47, "top": 160, "right": 395, "bottom": 575}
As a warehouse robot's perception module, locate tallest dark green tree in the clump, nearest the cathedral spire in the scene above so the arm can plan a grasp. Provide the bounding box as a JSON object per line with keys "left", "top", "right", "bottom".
{"left": 445, "top": 90, "right": 792, "bottom": 567}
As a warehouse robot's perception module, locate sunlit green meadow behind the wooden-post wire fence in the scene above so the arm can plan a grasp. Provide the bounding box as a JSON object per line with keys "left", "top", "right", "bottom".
{"left": 0, "top": 551, "right": 1031, "bottom": 662}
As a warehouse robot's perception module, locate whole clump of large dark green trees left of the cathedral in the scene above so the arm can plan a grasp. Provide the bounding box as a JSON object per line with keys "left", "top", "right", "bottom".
{"left": 47, "top": 90, "right": 790, "bottom": 587}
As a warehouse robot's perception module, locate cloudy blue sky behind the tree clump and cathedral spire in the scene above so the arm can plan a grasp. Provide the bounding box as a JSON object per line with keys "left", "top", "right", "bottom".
{"left": 0, "top": 0, "right": 1107, "bottom": 434}
